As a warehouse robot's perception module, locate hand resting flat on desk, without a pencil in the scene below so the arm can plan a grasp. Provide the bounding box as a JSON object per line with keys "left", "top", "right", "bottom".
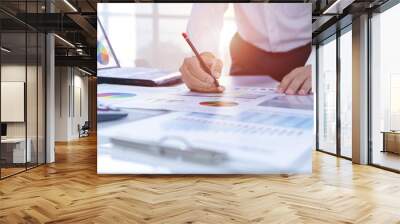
{"left": 277, "top": 65, "right": 311, "bottom": 95}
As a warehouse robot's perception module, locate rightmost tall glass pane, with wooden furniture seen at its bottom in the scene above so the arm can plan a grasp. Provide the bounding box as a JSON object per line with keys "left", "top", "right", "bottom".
{"left": 371, "top": 4, "right": 400, "bottom": 170}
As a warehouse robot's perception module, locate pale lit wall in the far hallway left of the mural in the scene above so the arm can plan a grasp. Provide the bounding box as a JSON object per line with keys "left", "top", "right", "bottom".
{"left": 55, "top": 67, "right": 88, "bottom": 141}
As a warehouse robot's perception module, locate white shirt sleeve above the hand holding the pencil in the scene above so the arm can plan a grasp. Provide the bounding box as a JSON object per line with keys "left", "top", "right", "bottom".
{"left": 187, "top": 3, "right": 228, "bottom": 56}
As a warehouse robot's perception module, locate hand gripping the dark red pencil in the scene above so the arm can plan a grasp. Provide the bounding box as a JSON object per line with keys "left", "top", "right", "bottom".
{"left": 179, "top": 52, "right": 225, "bottom": 92}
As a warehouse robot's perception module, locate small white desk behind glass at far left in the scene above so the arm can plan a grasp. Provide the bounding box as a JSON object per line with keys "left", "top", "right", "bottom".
{"left": 1, "top": 138, "right": 32, "bottom": 163}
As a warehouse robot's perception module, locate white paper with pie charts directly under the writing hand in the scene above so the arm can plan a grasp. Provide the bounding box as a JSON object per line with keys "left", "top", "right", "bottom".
{"left": 98, "top": 85, "right": 296, "bottom": 115}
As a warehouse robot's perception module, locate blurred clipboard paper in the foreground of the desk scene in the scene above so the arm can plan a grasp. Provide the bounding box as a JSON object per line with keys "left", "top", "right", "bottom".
{"left": 110, "top": 110, "right": 313, "bottom": 173}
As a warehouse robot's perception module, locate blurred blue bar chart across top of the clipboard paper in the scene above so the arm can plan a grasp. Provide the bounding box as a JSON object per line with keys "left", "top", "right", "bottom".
{"left": 162, "top": 111, "right": 313, "bottom": 136}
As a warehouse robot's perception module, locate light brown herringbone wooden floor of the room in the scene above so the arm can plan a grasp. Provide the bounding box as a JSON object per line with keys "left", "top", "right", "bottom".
{"left": 0, "top": 137, "right": 400, "bottom": 223}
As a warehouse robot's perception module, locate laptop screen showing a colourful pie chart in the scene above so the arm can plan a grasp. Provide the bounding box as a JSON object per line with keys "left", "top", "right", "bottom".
{"left": 97, "top": 19, "right": 119, "bottom": 69}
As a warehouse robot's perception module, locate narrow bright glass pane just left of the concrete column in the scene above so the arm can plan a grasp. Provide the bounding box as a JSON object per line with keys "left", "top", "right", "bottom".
{"left": 340, "top": 30, "right": 353, "bottom": 158}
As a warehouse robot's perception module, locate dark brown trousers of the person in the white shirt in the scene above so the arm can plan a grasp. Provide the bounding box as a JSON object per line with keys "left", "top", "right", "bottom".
{"left": 230, "top": 33, "right": 311, "bottom": 81}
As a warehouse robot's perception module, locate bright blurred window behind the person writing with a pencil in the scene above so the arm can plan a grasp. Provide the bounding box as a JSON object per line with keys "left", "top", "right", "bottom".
{"left": 98, "top": 3, "right": 236, "bottom": 74}
